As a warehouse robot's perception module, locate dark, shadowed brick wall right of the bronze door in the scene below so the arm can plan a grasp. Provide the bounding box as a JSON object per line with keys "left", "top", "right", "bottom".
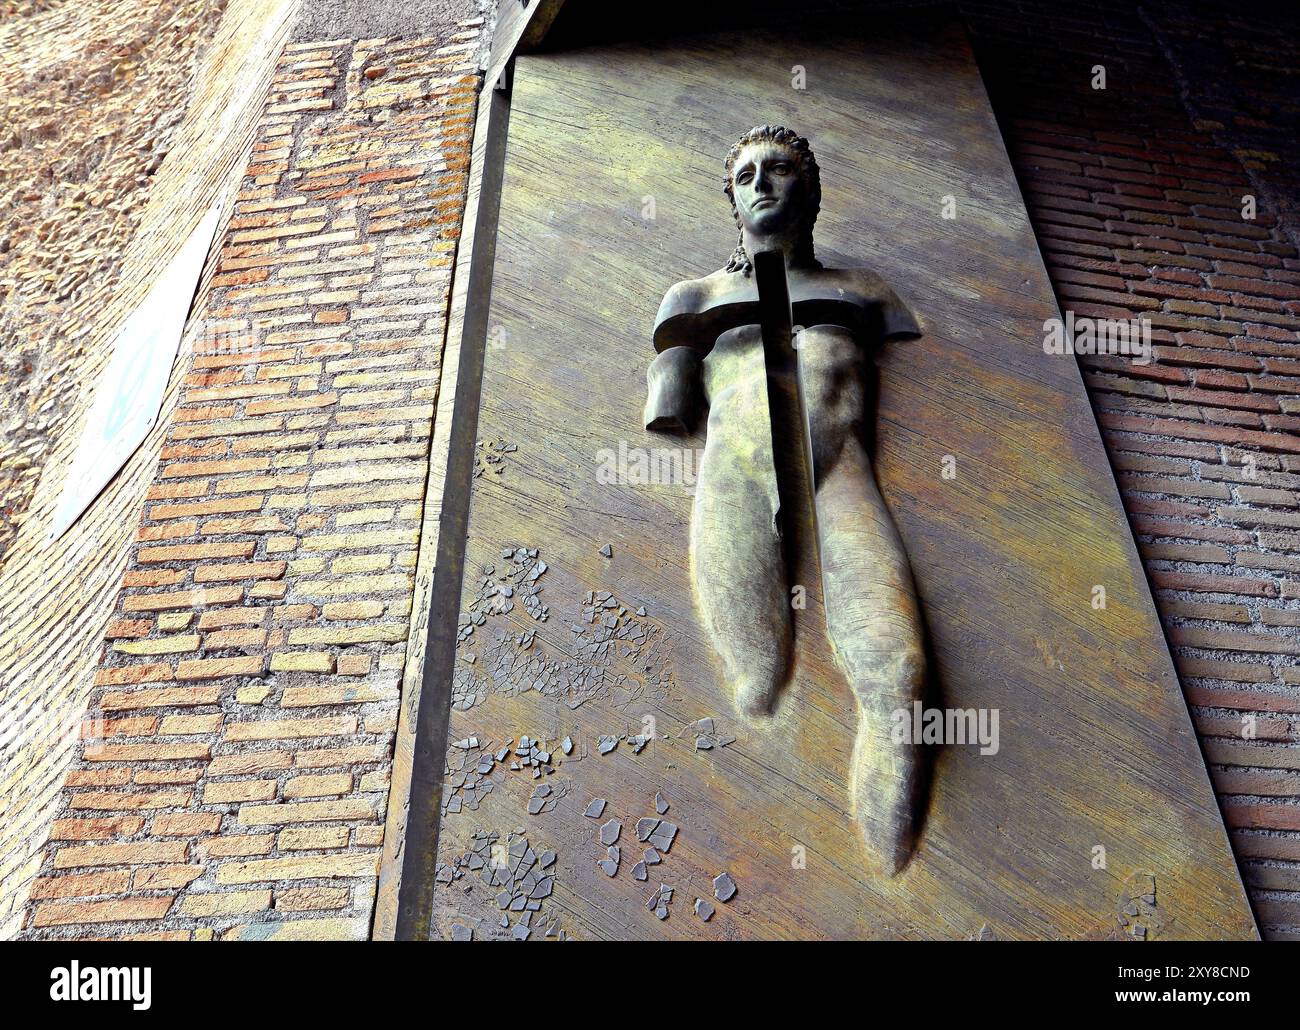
{"left": 963, "top": 3, "right": 1300, "bottom": 939}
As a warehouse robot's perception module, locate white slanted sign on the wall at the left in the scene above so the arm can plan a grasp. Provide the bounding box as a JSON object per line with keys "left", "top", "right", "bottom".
{"left": 48, "top": 207, "right": 221, "bottom": 541}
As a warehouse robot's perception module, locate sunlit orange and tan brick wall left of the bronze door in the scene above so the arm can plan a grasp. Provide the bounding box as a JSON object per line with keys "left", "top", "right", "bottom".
{"left": 19, "top": 20, "right": 481, "bottom": 939}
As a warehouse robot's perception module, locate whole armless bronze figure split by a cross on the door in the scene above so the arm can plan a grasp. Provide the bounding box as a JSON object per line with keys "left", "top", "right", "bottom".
{"left": 645, "top": 125, "right": 926, "bottom": 875}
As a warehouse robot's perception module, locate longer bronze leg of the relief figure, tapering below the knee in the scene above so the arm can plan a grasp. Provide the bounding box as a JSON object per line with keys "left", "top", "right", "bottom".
{"left": 816, "top": 437, "right": 926, "bottom": 875}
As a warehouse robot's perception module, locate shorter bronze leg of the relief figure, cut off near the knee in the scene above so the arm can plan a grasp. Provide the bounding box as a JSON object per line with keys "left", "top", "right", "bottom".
{"left": 690, "top": 398, "right": 790, "bottom": 715}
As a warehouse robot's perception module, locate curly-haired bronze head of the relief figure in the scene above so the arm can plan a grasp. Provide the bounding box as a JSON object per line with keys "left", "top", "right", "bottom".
{"left": 723, "top": 125, "right": 822, "bottom": 276}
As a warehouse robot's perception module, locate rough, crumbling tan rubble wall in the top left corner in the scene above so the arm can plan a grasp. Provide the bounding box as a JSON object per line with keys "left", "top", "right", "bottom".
{"left": 0, "top": 0, "right": 225, "bottom": 562}
